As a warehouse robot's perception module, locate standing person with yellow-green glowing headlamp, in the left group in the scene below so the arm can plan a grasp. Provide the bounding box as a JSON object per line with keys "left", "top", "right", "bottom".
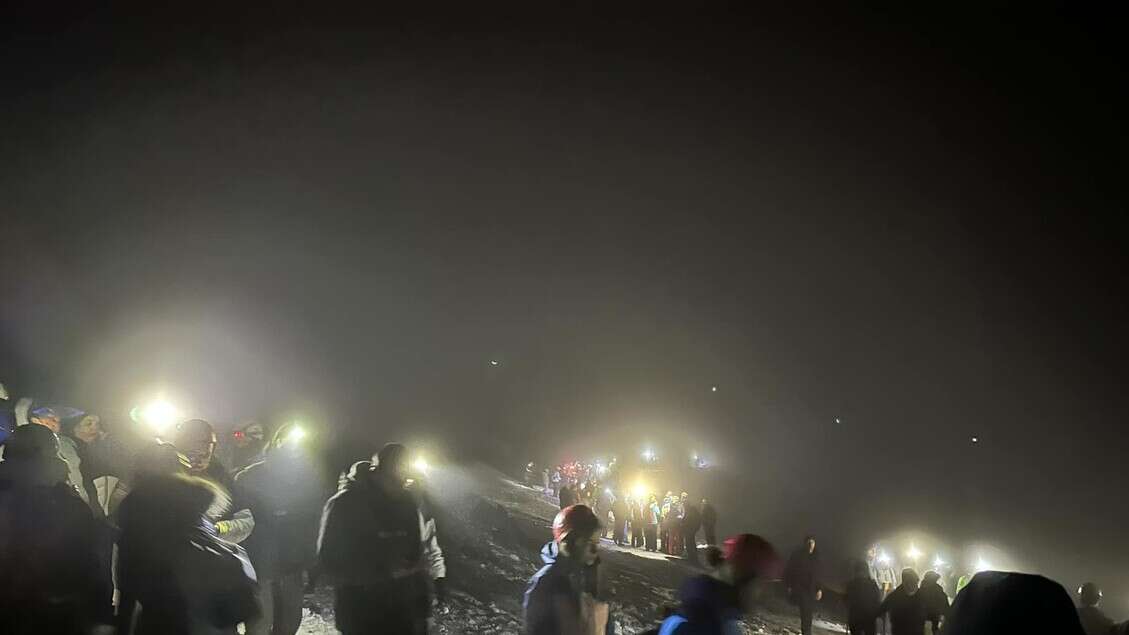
{"left": 235, "top": 423, "right": 325, "bottom": 635}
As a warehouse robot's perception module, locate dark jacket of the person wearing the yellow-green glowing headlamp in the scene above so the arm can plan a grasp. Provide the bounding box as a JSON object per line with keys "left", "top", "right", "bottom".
{"left": 235, "top": 447, "right": 325, "bottom": 580}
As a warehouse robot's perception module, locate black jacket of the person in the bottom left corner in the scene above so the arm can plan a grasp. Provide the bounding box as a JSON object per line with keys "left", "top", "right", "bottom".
{"left": 0, "top": 458, "right": 97, "bottom": 634}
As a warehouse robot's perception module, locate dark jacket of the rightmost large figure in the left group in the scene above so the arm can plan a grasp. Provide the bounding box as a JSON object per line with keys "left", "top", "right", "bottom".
{"left": 317, "top": 461, "right": 426, "bottom": 633}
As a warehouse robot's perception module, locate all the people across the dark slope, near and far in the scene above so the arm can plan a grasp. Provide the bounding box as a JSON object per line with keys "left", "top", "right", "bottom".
{"left": 0, "top": 379, "right": 1129, "bottom": 635}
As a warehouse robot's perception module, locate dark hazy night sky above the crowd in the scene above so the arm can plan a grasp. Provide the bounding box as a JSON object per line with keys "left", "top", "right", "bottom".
{"left": 0, "top": 2, "right": 1129, "bottom": 610}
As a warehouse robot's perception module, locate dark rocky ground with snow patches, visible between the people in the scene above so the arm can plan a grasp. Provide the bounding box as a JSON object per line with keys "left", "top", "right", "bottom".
{"left": 300, "top": 458, "right": 846, "bottom": 635}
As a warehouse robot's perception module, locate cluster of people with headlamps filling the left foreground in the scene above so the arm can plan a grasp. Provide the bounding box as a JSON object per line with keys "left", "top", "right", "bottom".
{"left": 0, "top": 384, "right": 446, "bottom": 635}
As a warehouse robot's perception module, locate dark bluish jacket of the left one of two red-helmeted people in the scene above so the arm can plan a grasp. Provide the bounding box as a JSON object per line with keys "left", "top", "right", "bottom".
{"left": 523, "top": 542, "right": 585, "bottom": 635}
